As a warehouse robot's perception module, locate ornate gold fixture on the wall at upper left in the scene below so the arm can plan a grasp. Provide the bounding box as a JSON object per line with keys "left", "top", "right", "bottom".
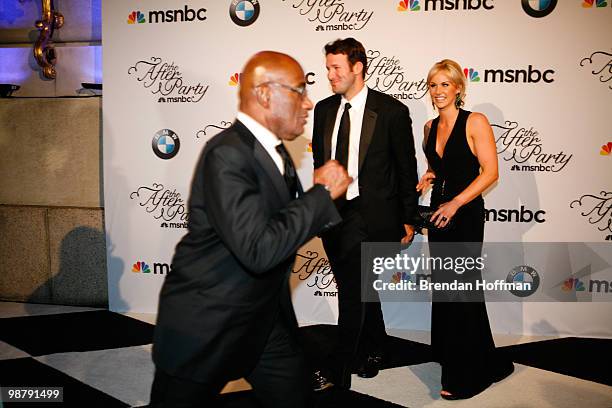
{"left": 34, "top": 0, "right": 64, "bottom": 79}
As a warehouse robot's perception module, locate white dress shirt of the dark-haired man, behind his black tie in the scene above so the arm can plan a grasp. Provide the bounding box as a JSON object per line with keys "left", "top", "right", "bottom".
{"left": 331, "top": 86, "right": 368, "bottom": 200}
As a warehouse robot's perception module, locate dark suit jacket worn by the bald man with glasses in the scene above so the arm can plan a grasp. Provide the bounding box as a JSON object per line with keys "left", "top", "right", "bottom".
{"left": 153, "top": 121, "right": 340, "bottom": 382}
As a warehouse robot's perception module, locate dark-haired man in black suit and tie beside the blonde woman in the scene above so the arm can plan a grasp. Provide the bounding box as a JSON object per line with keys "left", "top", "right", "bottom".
{"left": 312, "top": 38, "right": 417, "bottom": 391}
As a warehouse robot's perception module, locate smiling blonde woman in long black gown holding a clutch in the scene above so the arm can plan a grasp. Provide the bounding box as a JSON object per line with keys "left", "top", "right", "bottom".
{"left": 417, "top": 59, "right": 513, "bottom": 400}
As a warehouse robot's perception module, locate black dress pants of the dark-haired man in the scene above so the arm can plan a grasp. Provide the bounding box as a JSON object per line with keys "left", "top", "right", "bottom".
{"left": 323, "top": 198, "right": 386, "bottom": 370}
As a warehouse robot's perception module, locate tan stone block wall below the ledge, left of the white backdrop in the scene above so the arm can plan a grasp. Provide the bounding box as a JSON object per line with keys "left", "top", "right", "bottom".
{"left": 0, "top": 97, "right": 108, "bottom": 306}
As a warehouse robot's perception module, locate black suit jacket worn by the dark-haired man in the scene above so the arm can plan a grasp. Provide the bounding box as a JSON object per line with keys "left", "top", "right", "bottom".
{"left": 312, "top": 89, "right": 418, "bottom": 242}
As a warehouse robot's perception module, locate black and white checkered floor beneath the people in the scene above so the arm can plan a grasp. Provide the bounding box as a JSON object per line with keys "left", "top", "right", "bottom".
{"left": 0, "top": 302, "right": 612, "bottom": 408}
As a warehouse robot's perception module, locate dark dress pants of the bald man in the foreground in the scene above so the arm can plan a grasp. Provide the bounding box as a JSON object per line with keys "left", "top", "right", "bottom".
{"left": 149, "top": 319, "right": 310, "bottom": 408}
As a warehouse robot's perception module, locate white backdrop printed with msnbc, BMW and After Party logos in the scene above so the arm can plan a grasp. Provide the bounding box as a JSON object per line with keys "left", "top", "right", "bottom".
{"left": 102, "top": 0, "right": 612, "bottom": 337}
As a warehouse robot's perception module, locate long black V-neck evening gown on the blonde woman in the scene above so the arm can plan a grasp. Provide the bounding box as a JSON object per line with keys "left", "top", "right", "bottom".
{"left": 425, "top": 109, "right": 513, "bottom": 398}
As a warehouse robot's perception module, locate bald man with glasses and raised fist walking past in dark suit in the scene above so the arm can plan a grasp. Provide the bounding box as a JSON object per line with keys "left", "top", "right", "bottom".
{"left": 150, "top": 51, "right": 350, "bottom": 408}
